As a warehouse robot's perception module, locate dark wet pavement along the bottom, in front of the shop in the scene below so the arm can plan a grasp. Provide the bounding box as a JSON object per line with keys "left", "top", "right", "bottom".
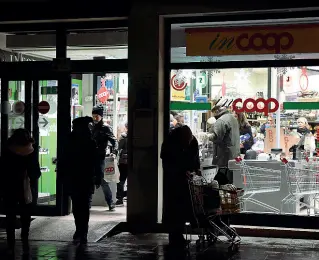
{"left": 0, "top": 234, "right": 319, "bottom": 260}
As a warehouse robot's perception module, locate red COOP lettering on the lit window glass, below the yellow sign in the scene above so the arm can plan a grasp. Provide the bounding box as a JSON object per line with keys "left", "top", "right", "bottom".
{"left": 232, "top": 98, "right": 279, "bottom": 116}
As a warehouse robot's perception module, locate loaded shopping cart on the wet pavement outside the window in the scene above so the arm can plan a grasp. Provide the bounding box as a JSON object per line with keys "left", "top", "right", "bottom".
{"left": 189, "top": 176, "right": 242, "bottom": 252}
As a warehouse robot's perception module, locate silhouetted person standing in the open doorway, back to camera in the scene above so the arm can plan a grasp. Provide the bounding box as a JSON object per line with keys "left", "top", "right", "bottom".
{"left": 58, "top": 117, "right": 101, "bottom": 245}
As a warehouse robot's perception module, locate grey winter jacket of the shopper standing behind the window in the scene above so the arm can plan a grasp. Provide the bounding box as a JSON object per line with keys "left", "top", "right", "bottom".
{"left": 209, "top": 110, "right": 240, "bottom": 167}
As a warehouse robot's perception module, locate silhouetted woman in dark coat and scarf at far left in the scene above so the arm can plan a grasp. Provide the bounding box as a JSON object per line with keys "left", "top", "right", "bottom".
{"left": 0, "top": 129, "right": 41, "bottom": 254}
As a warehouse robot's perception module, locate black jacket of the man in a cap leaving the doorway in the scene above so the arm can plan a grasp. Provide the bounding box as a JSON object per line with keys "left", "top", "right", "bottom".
{"left": 92, "top": 120, "right": 118, "bottom": 160}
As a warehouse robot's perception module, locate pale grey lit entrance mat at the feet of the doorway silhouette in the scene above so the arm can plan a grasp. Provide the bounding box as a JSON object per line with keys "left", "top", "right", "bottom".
{"left": 16, "top": 217, "right": 119, "bottom": 242}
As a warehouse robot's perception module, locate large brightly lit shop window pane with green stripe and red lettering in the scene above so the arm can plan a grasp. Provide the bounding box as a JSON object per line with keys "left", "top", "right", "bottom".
{"left": 170, "top": 67, "right": 319, "bottom": 215}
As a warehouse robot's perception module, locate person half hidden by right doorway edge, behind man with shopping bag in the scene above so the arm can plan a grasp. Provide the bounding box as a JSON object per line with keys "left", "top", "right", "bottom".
{"left": 115, "top": 123, "right": 128, "bottom": 206}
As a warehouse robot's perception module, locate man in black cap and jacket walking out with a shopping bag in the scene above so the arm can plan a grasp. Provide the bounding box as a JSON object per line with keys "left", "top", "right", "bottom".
{"left": 92, "top": 106, "right": 118, "bottom": 211}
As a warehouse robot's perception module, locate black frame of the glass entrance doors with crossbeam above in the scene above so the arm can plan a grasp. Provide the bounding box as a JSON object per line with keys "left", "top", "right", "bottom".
{"left": 0, "top": 59, "right": 128, "bottom": 216}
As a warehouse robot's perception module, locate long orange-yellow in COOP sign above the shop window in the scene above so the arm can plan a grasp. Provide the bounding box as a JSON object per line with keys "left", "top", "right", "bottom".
{"left": 186, "top": 24, "right": 319, "bottom": 56}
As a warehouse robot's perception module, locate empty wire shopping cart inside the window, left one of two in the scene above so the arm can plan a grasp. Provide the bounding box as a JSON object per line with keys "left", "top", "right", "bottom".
{"left": 235, "top": 157, "right": 281, "bottom": 214}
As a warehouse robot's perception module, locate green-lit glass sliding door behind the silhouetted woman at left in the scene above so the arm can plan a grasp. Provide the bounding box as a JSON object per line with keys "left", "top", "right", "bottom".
{"left": 1, "top": 78, "right": 58, "bottom": 215}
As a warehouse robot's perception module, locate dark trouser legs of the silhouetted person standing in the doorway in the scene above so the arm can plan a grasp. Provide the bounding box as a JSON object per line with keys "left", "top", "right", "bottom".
{"left": 71, "top": 192, "right": 92, "bottom": 238}
